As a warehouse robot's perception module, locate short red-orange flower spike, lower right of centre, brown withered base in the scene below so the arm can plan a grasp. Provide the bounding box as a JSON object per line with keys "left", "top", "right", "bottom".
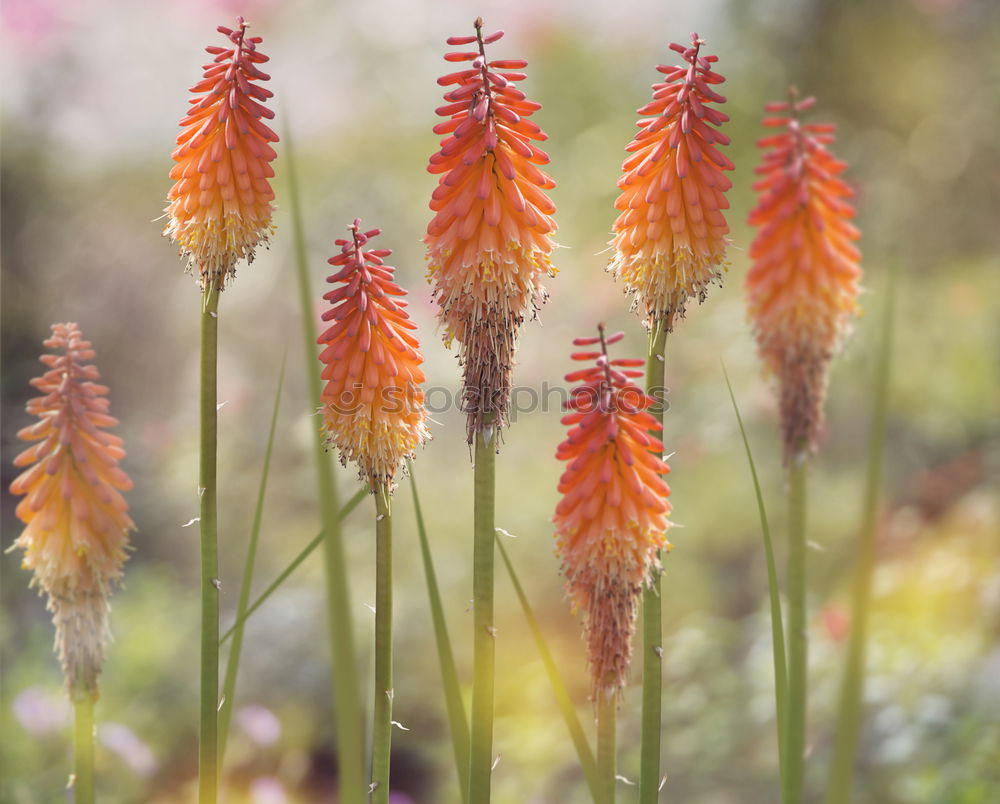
{"left": 553, "top": 326, "right": 670, "bottom": 701}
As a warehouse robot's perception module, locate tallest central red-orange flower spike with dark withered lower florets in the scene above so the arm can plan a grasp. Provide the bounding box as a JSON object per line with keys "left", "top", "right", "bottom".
{"left": 424, "top": 18, "right": 556, "bottom": 444}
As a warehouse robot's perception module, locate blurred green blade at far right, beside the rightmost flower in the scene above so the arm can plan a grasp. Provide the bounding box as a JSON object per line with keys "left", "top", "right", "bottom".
{"left": 826, "top": 273, "right": 894, "bottom": 804}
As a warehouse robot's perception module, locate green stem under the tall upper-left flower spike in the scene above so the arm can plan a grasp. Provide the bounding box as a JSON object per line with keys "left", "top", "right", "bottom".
{"left": 198, "top": 282, "right": 220, "bottom": 804}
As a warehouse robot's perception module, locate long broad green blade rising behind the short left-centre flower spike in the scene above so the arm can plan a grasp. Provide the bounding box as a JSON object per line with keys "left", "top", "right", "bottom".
{"left": 285, "top": 115, "right": 365, "bottom": 804}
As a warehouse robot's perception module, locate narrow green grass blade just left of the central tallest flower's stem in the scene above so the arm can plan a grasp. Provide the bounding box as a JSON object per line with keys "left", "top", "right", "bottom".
{"left": 407, "top": 461, "right": 469, "bottom": 803}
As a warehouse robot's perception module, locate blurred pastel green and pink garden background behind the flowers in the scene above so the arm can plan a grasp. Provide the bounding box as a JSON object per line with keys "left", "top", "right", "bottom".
{"left": 0, "top": 0, "right": 1000, "bottom": 804}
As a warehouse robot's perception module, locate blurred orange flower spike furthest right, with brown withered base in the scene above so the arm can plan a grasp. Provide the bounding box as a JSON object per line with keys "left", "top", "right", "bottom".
{"left": 746, "top": 90, "right": 861, "bottom": 459}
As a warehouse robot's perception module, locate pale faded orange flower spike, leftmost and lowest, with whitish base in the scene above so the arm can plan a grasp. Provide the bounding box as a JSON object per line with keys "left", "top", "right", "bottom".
{"left": 10, "top": 324, "right": 135, "bottom": 695}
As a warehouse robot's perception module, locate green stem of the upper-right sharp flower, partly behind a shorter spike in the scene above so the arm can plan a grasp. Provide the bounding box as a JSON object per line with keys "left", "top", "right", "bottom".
{"left": 639, "top": 321, "right": 668, "bottom": 804}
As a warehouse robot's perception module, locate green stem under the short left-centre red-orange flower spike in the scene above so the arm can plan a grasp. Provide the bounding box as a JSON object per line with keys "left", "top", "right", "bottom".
{"left": 372, "top": 485, "right": 392, "bottom": 804}
